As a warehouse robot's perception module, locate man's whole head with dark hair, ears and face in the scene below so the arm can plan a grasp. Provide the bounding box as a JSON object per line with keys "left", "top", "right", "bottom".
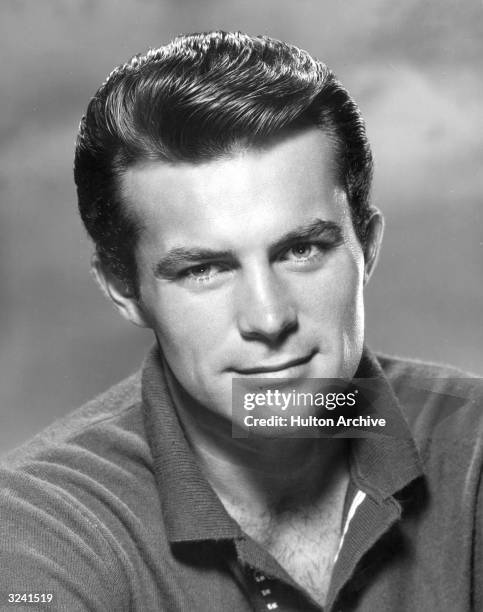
{"left": 76, "top": 33, "right": 381, "bottom": 428}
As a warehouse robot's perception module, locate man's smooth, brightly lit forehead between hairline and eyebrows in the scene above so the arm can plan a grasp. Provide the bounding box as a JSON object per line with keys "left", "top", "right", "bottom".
{"left": 117, "top": 128, "right": 351, "bottom": 249}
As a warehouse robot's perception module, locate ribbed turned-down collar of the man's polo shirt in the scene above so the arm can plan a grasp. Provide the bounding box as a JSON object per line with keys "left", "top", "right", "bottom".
{"left": 142, "top": 347, "right": 422, "bottom": 543}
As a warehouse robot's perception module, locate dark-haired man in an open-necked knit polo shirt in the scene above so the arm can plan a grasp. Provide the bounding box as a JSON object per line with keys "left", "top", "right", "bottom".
{"left": 0, "top": 32, "right": 483, "bottom": 611}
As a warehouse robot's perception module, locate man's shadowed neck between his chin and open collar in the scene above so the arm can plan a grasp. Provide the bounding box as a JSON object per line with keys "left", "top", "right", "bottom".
{"left": 166, "top": 360, "right": 348, "bottom": 515}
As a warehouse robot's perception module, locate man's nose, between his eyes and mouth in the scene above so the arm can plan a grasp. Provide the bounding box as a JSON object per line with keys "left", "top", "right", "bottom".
{"left": 237, "top": 266, "right": 298, "bottom": 345}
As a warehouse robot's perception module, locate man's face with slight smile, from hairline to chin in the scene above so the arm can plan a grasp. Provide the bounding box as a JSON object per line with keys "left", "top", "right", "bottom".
{"left": 122, "top": 129, "right": 374, "bottom": 424}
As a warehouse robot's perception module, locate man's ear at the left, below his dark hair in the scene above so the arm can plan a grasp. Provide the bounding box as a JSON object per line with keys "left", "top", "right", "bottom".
{"left": 91, "top": 253, "right": 150, "bottom": 327}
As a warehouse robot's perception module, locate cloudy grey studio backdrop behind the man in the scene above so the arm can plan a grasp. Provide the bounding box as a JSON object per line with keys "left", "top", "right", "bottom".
{"left": 0, "top": 0, "right": 483, "bottom": 452}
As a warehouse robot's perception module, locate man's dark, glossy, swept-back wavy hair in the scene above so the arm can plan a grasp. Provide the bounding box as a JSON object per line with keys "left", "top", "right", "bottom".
{"left": 74, "top": 31, "right": 372, "bottom": 291}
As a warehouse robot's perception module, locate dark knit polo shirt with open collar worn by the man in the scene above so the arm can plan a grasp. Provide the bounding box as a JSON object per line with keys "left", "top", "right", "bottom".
{"left": 0, "top": 349, "right": 483, "bottom": 612}
